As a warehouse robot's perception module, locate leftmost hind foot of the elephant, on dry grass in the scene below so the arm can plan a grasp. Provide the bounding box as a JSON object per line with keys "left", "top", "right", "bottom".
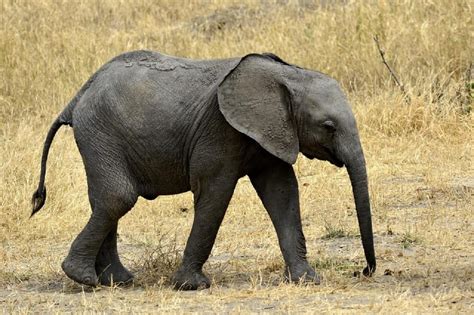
{"left": 61, "top": 255, "right": 99, "bottom": 287}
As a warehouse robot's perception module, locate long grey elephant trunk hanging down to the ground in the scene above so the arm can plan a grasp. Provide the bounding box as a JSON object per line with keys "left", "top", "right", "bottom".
{"left": 338, "top": 137, "right": 376, "bottom": 276}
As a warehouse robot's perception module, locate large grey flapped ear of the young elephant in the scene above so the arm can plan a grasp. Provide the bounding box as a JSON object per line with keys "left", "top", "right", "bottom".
{"left": 217, "top": 54, "right": 299, "bottom": 164}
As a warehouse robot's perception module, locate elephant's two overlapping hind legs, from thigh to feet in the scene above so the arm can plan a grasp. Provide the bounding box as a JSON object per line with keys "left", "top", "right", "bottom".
{"left": 62, "top": 163, "right": 138, "bottom": 286}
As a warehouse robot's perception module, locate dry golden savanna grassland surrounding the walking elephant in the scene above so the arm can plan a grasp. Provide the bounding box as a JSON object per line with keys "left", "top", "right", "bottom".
{"left": 0, "top": 0, "right": 474, "bottom": 313}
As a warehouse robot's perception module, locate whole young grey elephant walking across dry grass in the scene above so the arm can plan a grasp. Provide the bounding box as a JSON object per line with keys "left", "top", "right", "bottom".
{"left": 33, "top": 51, "right": 375, "bottom": 289}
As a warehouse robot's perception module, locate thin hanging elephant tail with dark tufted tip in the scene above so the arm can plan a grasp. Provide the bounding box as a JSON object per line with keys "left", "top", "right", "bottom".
{"left": 31, "top": 110, "right": 73, "bottom": 217}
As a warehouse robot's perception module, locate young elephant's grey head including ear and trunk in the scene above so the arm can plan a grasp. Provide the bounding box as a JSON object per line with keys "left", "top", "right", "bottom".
{"left": 218, "top": 54, "right": 376, "bottom": 276}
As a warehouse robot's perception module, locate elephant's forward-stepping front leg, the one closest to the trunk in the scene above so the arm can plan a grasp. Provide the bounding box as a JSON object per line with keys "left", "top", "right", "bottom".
{"left": 249, "top": 158, "right": 320, "bottom": 284}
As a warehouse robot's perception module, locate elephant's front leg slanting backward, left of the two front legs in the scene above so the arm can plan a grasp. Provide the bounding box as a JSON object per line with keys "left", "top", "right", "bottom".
{"left": 172, "top": 179, "right": 236, "bottom": 290}
